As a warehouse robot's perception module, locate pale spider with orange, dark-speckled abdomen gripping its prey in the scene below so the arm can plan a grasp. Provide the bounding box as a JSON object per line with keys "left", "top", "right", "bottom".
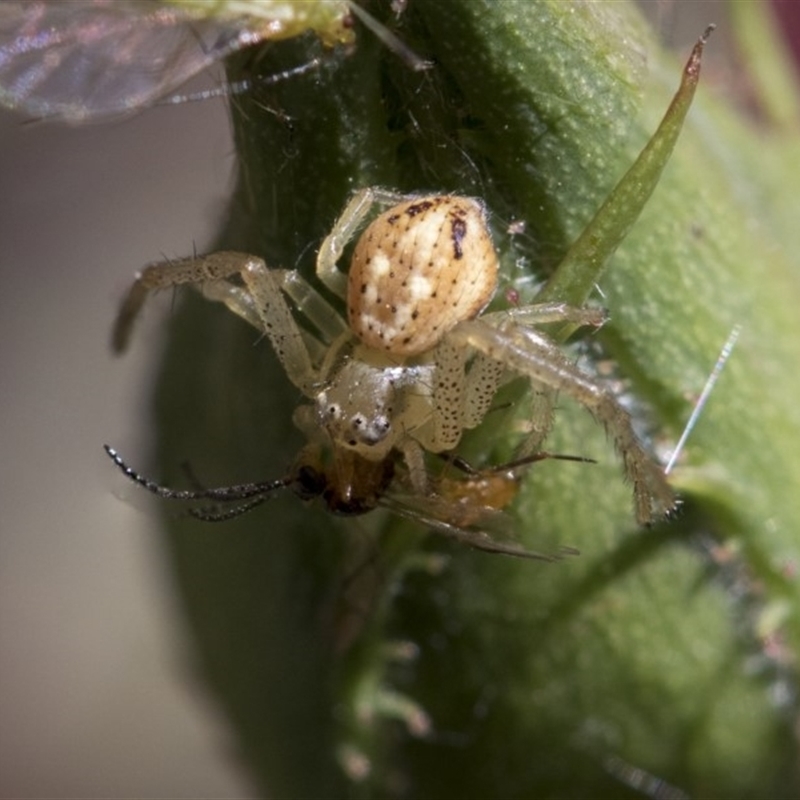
{"left": 114, "top": 188, "right": 675, "bottom": 524}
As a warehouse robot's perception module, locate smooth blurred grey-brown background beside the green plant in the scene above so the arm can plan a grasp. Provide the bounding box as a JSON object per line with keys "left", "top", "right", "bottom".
{"left": 0, "top": 0, "right": 796, "bottom": 798}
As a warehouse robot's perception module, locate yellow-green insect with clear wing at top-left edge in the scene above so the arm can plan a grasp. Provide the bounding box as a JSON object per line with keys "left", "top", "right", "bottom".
{"left": 0, "top": 0, "right": 427, "bottom": 123}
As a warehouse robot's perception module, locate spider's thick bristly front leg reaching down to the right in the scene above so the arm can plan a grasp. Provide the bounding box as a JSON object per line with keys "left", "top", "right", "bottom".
{"left": 450, "top": 319, "right": 675, "bottom": 524}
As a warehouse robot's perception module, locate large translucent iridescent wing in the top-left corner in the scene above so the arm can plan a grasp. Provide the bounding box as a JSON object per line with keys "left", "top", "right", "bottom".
{"left": 0, "top": 0, "right": 259, "bottom": 122}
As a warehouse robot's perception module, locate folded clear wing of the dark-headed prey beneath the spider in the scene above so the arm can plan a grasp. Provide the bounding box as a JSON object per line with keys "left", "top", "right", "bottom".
{"left": 380, "top": 493, "right": 567, "bottom": 561}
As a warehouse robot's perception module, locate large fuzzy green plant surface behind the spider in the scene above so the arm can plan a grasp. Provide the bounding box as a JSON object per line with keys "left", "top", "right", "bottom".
{"left": 147, "top": 0, "right": 800, "bottom": 797}
